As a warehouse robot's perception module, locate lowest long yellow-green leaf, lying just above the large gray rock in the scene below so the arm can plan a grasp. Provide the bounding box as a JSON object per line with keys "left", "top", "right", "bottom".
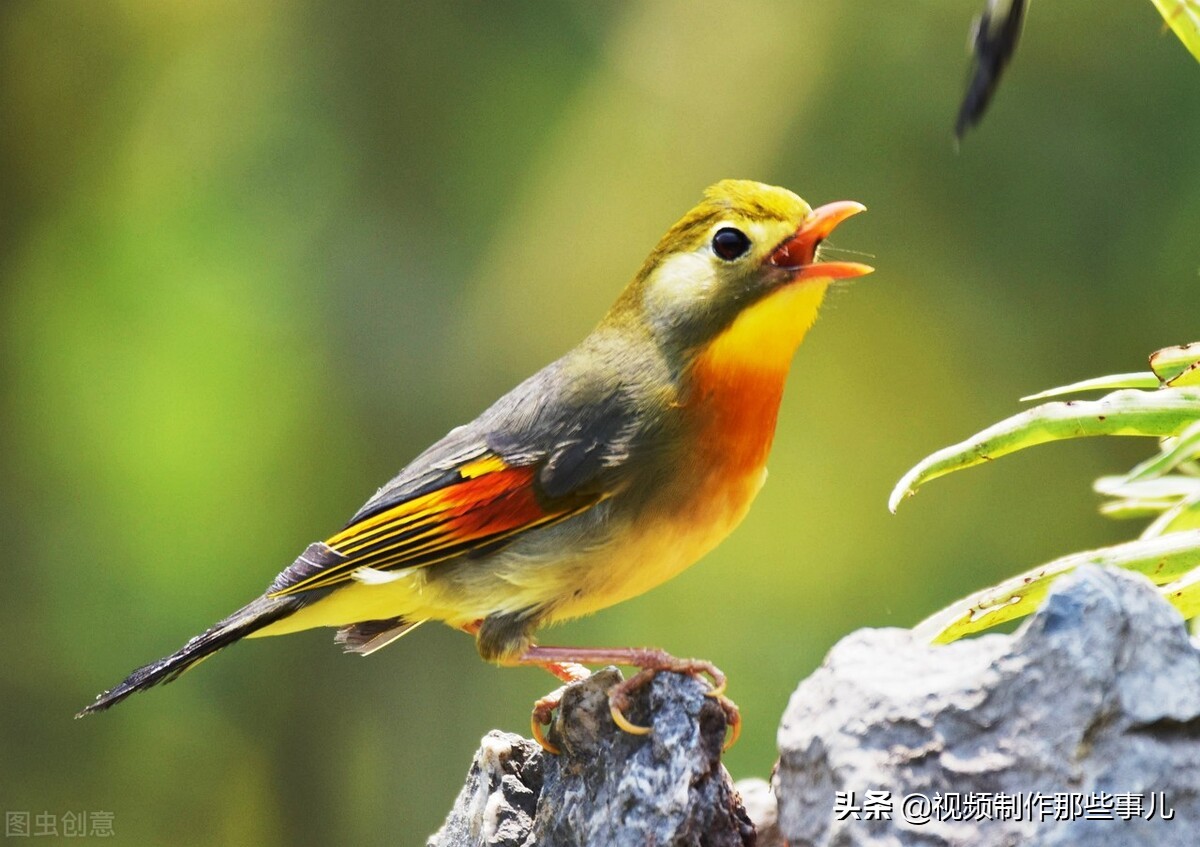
{"left": 913, "top": 530, "right": 1200, "bottom": 644}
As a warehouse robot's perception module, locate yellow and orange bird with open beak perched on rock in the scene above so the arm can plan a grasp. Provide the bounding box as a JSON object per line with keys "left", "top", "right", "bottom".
{"left": 79, "top": 180, "right": 872, "bottom": 749}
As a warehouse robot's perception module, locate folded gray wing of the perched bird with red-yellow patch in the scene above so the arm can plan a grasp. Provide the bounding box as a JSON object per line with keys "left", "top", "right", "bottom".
{"left": 268, "top": 366, "right": 636, "bottom": 596}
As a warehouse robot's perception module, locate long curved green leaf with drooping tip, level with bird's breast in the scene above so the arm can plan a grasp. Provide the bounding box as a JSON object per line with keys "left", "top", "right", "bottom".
{"left": 888, "top": 389, "right": 1200, "bottom": 512}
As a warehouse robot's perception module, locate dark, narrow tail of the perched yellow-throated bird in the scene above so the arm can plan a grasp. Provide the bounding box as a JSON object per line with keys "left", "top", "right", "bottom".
{"left": 76, "top": 596, "right": 304, "bottom": 717}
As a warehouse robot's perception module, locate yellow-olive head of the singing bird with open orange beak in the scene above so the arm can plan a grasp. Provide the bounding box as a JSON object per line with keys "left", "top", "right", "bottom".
{"left": 610, "top": 180, "right": 872, "bottom": 358}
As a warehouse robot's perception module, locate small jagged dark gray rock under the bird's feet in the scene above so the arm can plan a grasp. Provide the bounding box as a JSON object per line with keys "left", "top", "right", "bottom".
{"left": 428, "top": 669, "right": 754, "bottom": 847}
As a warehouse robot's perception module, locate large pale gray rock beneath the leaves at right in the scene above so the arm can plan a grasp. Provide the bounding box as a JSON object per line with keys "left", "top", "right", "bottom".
{"left": 776, "top": 566, "right": 1200, "bottom": 847}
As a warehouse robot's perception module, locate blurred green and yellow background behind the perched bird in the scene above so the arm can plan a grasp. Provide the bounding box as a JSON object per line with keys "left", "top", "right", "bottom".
{"left": 0, "top": 0, "right": 1200, "bottom": 846}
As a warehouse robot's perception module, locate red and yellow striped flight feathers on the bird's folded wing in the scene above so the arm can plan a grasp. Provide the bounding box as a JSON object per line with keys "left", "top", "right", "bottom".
{"left": 270, "top": 456, "right": 595, "bottom": 597}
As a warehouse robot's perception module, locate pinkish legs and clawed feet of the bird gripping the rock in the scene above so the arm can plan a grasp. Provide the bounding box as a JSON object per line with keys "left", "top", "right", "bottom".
{"left": 514, "top": 645, "right": 742, "bottom": 752}
